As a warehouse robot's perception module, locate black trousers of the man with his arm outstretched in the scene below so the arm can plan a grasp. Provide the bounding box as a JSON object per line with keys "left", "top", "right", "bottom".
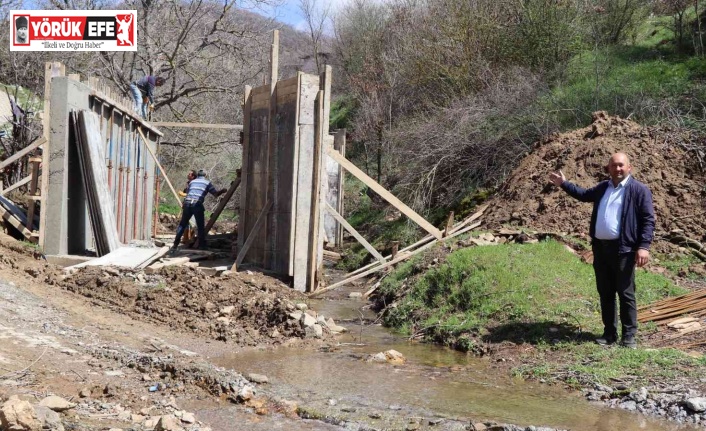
{"left": 593, "top": 239, "right": 637, "bottom": 339}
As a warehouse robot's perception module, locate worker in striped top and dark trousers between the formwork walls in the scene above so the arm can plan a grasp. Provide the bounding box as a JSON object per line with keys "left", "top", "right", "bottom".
{"left": 169, "top": 170, "right": 227, "bottom": 255}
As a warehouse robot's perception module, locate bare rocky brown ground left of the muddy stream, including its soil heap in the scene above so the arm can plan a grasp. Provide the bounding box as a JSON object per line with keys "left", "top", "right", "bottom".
{"left": 0, "top": 234, "right": 572, "bottom": 431}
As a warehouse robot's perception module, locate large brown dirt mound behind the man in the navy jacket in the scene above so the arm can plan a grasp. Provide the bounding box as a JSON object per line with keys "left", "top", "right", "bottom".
{"left": 484, "top": 112, "right": 706, "bottom": 250}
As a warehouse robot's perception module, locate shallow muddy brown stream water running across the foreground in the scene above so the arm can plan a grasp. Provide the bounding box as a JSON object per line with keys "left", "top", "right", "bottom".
{"left": 210, "top": 299, "right": 697, "bottom": 431}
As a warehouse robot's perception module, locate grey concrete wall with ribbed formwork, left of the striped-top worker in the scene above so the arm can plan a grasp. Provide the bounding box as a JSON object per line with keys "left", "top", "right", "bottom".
{"left": 42, "top": 77, "right": 157, "bottom": 255}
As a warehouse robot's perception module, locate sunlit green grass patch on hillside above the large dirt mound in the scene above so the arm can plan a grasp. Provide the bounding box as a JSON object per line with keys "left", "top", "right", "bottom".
{"left": 537, "top": 46, "right": 706, "bottom": 129}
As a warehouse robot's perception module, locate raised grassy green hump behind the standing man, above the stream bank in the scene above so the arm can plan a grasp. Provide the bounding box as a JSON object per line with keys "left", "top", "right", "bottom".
{"left": 381, "top": 241, "right": 683, "bottom": 350}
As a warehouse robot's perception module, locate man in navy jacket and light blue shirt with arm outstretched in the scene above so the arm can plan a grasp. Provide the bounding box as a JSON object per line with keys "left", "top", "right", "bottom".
{"left": 549, "top": 153, "right": 655, "bottom": 349}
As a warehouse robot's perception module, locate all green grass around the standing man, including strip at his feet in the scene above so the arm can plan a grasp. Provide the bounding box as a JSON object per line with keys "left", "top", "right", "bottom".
{"left": 379, "top": 241, "right": 706, "bottom": 386}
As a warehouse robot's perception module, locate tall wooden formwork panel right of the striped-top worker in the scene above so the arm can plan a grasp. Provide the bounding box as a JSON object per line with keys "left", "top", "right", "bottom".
{"left": 238, "top": 73, "right": 323, "bottom": 291}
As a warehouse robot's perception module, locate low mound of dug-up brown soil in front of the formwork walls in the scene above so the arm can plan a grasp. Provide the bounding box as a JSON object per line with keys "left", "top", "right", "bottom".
{"left": 57, "top": 267, "right": 318, "bottom": 346}
